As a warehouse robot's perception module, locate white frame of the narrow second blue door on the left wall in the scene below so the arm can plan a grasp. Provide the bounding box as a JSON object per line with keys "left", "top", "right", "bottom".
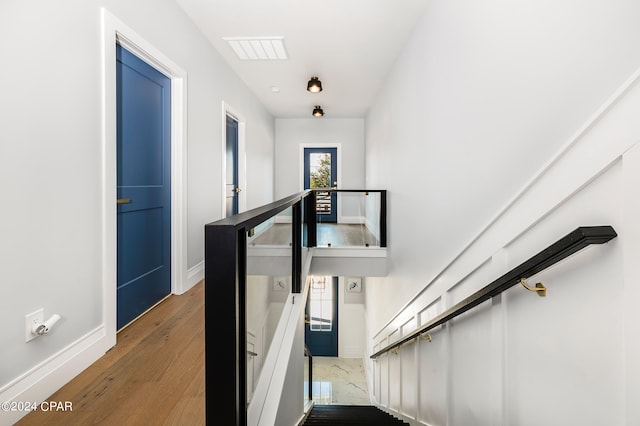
{"left": 220, "top": 101, "right": 247, "bottom": 218}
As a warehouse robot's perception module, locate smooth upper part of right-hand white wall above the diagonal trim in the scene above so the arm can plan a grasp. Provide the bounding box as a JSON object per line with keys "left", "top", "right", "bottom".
{"left": 366, "top": 0, "right": 640, "bottom": 329}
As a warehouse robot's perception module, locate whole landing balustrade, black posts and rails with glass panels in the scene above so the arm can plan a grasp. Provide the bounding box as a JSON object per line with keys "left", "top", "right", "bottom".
{"left": 204, "top": 188, "right": 387, "bottom": 424}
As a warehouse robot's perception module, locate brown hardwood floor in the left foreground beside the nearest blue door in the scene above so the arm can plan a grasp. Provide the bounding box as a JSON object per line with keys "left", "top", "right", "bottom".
{"left": 16, "top": 282, "right": 205, "bottom": 426}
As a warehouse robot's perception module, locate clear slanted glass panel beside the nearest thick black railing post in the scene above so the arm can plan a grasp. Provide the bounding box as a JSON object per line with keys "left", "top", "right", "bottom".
{"left": 246, "top": 208, "right": 293, "bottom": 402}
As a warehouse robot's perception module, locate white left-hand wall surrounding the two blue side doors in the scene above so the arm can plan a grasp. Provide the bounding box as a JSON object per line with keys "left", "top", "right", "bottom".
{"left": 0, "top": 0, "right": 274, "bottom": 422}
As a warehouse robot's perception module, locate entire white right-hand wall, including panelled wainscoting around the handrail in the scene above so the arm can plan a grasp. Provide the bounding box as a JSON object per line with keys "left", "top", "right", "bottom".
{"left": 366, "top": 1, "right": 640, "bottom": 425}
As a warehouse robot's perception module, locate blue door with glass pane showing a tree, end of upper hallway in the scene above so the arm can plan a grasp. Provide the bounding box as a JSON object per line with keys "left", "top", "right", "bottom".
{"left": 304, "top": 148, "right": 338, "bottom": 223}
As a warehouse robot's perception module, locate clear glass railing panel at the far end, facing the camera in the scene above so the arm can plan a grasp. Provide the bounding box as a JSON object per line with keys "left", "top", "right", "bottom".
{"left": 315, "top": 190, "right": 384, "bottom": 247}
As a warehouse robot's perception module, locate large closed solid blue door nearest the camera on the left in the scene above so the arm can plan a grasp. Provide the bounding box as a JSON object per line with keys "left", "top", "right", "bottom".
{"left": 116, "top": 45, "right": 171, "bottom": 329}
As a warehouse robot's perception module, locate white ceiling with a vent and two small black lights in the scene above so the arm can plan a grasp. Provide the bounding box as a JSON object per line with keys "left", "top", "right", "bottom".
{"left": 176, "top": 0, "right": 429, "bottom": 118}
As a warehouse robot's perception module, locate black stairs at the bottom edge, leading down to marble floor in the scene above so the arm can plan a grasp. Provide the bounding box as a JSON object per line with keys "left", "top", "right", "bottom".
{"left": 302, "top": 405, "right": 408, "bottom": 426}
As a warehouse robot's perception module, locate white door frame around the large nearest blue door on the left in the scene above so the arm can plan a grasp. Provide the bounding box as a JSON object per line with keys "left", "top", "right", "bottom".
{"left": 102, "top": 8, "right": 187, "bottom": 350}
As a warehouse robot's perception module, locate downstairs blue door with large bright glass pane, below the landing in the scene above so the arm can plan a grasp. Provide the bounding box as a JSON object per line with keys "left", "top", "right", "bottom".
{"left": 304, "top": 276, "right": 338, "bottom": 356}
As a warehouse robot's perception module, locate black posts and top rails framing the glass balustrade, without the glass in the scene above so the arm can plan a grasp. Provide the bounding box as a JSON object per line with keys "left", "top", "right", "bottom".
{"left": 204, "top": 189, "right": 387, "bottom": 426}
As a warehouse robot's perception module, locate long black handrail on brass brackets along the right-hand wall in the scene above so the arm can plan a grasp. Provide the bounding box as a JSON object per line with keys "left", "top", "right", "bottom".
{"left": 370, "top": 226, "right": 618, "bottom": 359}
